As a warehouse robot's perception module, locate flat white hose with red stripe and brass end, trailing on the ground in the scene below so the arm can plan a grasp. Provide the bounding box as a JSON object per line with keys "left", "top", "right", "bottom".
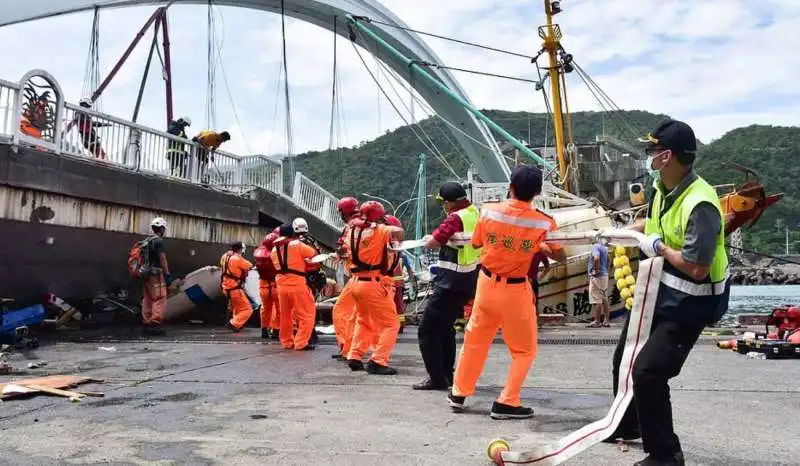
{"left": 487, "top": 229, "right": 664, "bottom": 466}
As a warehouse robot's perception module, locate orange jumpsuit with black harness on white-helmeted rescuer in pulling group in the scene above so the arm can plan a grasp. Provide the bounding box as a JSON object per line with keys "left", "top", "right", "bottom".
{"left": 272, "top": 239, "right": 317, "bottom": 350}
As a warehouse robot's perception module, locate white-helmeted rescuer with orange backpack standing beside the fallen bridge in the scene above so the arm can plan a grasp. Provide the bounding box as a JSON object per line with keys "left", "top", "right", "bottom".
{"left": 142, "top": 217, "right": 172, "bottom": 336}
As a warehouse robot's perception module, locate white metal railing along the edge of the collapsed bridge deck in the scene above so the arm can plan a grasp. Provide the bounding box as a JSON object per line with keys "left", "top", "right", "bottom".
{"left": 0, "top": 70, "right": 342, "bottom": 228}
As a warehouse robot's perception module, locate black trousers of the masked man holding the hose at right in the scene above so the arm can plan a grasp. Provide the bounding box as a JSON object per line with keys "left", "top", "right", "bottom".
{"left": 612, "top": 314, "right": 703, "bottom": 459}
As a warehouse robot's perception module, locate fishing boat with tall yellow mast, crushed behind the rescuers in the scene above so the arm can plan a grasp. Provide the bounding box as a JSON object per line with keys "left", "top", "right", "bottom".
{"left": 400, "top": 0, "right": 783, "bottom": 321}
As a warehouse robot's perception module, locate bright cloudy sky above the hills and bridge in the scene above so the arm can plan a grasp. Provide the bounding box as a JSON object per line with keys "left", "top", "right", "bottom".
{"left": 0, "top": 0, "right": 800, "bottom": 158}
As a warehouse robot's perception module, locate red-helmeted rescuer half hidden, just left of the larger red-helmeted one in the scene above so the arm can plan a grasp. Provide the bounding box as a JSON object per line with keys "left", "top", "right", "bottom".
{"left": 331, "top": 197, "right": 361, "bottom": 361}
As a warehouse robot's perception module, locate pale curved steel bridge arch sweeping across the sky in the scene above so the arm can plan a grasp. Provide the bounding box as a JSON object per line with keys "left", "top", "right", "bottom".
{"left": 0, "top": 0, "right": 509, "bottom": 182}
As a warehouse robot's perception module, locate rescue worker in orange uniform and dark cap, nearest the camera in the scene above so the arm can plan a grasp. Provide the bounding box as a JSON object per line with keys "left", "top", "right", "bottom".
{"left": 448, "top": 165, "right": 566, "bottom": 419}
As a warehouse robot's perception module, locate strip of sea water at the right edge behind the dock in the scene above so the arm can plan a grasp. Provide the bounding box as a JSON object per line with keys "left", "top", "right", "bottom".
{"left": 720, "top": 285, "right": 800, "bottom": 325}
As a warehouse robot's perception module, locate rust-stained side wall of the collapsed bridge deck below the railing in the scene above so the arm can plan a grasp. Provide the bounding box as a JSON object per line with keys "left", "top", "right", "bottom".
{"left": 0, "top": 186, "right": 269, "bottom": 245}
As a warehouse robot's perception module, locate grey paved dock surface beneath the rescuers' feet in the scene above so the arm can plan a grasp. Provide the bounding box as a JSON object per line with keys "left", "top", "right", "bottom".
{"left": 0, "top": 328, "right": 800, "bottom": 466}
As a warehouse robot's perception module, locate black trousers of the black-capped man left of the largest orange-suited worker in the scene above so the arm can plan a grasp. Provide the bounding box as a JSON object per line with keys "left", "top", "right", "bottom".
{"left": 417, "top": 286, "right": 475, "bottom": 383}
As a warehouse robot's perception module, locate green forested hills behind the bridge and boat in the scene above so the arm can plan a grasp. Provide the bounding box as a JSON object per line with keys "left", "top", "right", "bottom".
{"left": 285, "top": 110, "right": 800, "bottom": 253}
